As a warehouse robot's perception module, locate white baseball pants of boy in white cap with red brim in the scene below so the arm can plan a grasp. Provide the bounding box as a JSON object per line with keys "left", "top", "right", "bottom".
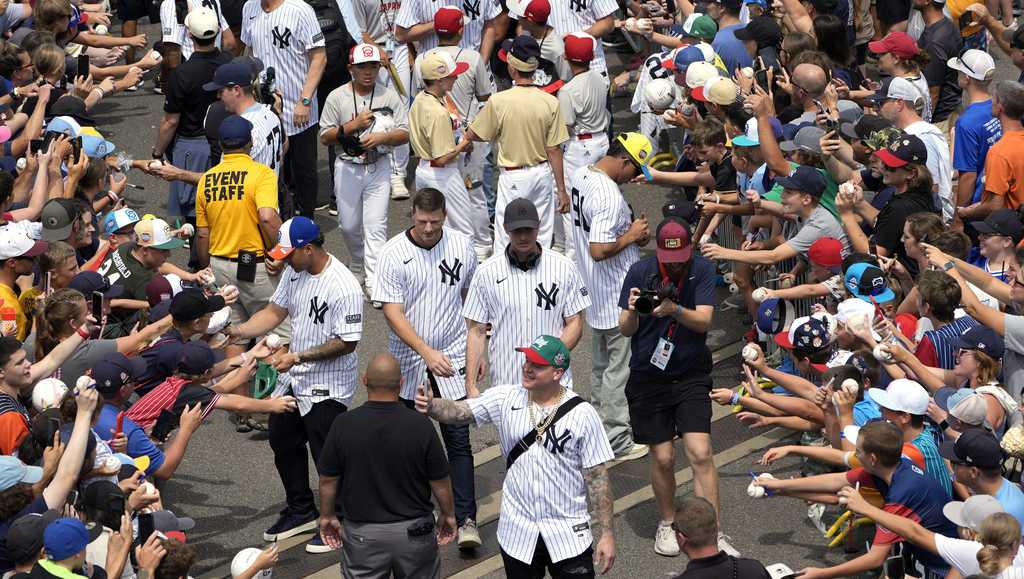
{"left": 334, "top": 157, "right": 391, "bottom": 288}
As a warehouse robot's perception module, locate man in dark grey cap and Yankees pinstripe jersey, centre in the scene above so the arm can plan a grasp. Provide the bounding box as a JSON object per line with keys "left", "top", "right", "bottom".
{"left": 462, "top": 198, "right": 590, "bottom": 392}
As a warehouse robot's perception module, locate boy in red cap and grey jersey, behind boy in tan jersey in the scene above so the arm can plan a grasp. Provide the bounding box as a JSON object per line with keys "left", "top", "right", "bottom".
{"left": 413, "top": 6, "right": 496, "bottom": 260}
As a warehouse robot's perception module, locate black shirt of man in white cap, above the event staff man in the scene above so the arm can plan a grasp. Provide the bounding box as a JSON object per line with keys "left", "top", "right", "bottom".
{"left": 164, "top": 50, "right": 231, "bottom": 137}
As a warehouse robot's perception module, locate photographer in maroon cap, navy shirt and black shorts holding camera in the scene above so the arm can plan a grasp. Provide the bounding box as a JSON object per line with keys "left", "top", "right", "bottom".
{"left": 618, "top": 217, "right": 739, "bottom": 556}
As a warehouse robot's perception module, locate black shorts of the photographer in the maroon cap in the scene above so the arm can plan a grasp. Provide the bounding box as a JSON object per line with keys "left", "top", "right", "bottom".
{"left": 626, "top": 372, "right": 713, "bottom": 445}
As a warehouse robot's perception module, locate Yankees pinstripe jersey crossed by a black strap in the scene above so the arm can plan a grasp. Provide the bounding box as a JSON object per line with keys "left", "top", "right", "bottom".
{"left": 466, "top": 384, "right": 614, "bottom": 563}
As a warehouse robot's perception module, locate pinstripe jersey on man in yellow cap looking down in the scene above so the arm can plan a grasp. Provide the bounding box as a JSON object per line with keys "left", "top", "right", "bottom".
{"left": 569, "top": 166, "right": 640, "bottom": 330}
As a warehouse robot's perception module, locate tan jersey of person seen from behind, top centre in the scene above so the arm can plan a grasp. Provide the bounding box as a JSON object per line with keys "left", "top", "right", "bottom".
{"left": 469, "top": 86, "right": 569, "bottom": 167}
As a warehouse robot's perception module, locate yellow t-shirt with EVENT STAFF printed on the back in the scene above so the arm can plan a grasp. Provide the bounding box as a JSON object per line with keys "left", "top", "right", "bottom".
{"left": 196, "top": 153, "right": 278, "bottom": 259}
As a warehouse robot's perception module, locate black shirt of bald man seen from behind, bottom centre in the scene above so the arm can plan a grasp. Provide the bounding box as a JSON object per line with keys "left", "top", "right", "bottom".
{"left": 319, "top": 401, "right": 449, "bottom": 523}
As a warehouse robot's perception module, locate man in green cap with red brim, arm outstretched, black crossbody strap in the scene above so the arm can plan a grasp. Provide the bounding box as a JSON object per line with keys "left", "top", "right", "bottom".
{"left": 416, "top": 335, "right": 615, "bottom": 579}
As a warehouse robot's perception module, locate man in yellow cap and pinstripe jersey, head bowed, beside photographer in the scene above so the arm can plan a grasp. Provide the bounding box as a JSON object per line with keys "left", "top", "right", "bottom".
{"left": 571, "top": 131, "right": 653, "bottom": 459}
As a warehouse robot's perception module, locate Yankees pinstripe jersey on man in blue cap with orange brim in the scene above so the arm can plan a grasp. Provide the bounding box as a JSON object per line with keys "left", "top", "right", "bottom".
{"left": 270, "top": 255, "right": 362, "bottom": 415}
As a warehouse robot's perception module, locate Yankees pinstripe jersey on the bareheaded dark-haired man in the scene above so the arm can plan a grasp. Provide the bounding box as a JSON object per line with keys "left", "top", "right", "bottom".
{"left": 373, "top": 228, "right": 477, "bottom": 400}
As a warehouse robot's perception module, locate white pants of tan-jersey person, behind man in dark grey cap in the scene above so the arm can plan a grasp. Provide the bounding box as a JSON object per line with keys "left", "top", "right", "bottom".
{"left": 495, "top": 162, "right": 555, "bottom": 254}
